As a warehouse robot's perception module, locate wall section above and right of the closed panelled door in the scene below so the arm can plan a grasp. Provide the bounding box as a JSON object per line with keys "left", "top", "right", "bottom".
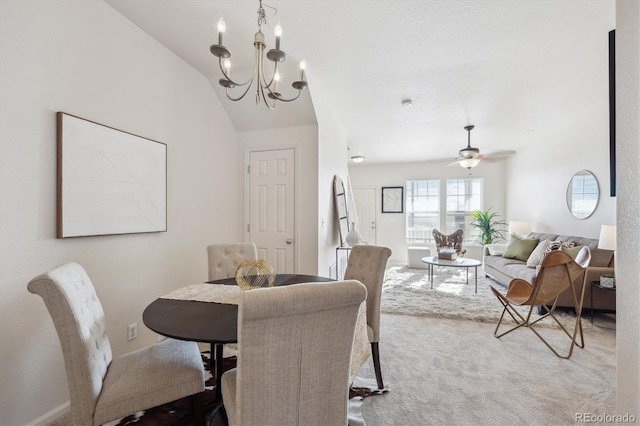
{"left": 238, "top": 125, "right": 318, "bottom": 275}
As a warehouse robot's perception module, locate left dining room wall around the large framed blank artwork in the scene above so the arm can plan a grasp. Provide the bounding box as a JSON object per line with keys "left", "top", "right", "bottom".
{"left": 0, "top": 1, "right": 243, "bottom": 425}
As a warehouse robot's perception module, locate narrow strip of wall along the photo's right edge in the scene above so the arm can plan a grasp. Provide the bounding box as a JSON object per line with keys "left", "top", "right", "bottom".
{"left": 616, "top": 0, "right": 640, "bottom": 421}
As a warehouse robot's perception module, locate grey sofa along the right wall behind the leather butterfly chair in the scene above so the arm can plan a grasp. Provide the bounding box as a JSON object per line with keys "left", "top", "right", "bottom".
{"left": 482, "top": 232, "right": 616, "bottom": 311}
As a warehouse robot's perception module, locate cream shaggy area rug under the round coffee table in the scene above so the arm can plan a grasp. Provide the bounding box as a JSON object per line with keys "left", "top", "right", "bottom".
{"left": 380, "top": 266, "right": 588, "bottom": 327}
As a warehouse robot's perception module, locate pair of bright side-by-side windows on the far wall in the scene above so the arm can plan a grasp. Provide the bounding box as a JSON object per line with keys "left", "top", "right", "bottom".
{"left": 406, "top": 178, "right": 483, "bottom": 242}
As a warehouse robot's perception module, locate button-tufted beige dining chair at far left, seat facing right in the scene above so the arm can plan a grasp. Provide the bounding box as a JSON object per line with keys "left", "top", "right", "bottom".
{"left": 27, "top": 263, "right": 204, "bottom": 426}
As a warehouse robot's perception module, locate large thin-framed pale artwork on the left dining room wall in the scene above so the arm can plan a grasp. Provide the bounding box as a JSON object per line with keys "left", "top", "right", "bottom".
{"left": 57, "top": 112, "right": 167, "bottom": 238}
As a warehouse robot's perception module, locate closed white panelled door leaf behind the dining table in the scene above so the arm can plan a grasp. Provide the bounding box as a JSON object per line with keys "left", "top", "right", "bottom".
{"left": 248, "top": 149, "right": 295, "bottom": 274}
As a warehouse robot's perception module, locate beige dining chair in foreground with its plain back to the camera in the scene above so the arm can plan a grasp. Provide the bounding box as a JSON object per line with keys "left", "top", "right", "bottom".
{"left": 222, "top": 280, "right": 367, "bottom": 426}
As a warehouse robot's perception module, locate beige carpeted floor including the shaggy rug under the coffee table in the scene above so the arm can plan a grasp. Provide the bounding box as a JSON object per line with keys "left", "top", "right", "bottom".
{"left": 358, "top": 267, "right": 616, "bottom": 426}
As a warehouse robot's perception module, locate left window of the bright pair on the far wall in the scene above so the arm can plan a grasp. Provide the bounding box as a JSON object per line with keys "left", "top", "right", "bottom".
{"left": 406, "top": 179, "right": 440, "bottom": 242}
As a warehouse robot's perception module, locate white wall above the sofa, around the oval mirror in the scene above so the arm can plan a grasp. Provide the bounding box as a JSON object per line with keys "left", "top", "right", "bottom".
{"left": 507, "top": 102, "right": 616, "bottom": 238}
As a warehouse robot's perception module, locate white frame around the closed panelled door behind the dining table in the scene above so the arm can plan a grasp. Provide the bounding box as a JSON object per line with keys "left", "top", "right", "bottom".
{"left": 242, "top": 145, "right": 300, "bottom": 274}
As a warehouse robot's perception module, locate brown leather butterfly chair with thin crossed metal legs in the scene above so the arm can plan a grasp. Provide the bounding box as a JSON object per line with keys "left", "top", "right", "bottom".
{"left": 491, "top": 248, "right": 590, "bottom": 359}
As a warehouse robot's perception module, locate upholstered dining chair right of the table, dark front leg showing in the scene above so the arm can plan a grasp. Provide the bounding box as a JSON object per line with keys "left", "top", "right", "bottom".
{"left": 344, "top": 245, "right": 391, "bottom": 389}
